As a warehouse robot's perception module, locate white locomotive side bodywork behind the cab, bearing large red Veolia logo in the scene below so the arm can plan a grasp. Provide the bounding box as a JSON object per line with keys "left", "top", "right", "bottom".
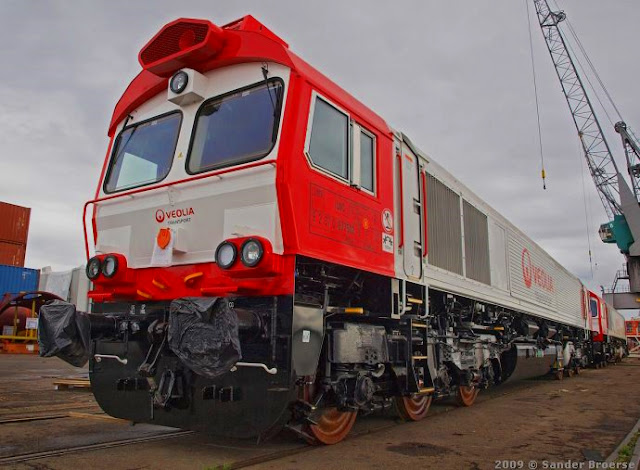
{"left": 394, "top": 133, "right": 588, "bottom": 329}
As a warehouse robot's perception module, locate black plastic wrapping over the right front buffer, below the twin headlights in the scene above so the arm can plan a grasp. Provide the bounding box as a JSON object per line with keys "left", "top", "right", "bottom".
{"left": 168, "top": 297, "right": 242, "bottom": 378}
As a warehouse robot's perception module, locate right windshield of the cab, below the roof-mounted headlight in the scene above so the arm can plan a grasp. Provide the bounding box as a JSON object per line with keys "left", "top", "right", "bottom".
{"left": 187, "top": 80, "right": 282, "bottom": 173}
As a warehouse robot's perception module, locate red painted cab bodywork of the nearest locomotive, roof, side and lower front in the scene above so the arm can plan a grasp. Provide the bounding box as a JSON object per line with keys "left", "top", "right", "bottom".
{"left": 92, "top": 17, "right": 394, "bottom": 301}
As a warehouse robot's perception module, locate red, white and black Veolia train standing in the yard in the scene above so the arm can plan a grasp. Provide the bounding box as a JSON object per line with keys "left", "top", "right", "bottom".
{"left": 39, "top": 16, "right": 626, "bottom": 444}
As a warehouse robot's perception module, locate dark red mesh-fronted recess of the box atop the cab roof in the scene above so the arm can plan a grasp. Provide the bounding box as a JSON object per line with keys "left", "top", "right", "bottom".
{"left": 140, "top": 22, "right": 209, "bottom": 66}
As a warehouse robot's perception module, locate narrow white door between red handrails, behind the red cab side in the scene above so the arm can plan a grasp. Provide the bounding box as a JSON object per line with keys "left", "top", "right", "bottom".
{"left": 396, "top": 143, "right": 423, "bottom": 280}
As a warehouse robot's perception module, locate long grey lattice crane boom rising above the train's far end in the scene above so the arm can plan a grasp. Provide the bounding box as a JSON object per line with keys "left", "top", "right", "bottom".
{"left": 534, "top": 0, "right": 622, "bottom": 220}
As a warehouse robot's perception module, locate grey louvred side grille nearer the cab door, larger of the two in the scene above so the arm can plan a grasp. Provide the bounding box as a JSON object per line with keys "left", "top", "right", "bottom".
{"left": 427, "top": 175, "right": 462, "bottom": 275}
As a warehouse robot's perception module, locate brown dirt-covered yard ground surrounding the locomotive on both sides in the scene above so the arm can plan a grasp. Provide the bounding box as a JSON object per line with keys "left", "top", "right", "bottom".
{"left": 0, "top": 355, "right": 640, "bottom": 470}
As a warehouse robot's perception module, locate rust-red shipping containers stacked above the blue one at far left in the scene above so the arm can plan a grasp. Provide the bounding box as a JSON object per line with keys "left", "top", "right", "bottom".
{"left": 0, "top": 202, "right": 31, "bottom": 267}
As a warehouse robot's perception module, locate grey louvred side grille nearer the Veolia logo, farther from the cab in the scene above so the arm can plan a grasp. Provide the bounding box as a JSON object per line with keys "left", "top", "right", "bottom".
{"left": 462, "top": 199, "right": 491, "bottom": 284}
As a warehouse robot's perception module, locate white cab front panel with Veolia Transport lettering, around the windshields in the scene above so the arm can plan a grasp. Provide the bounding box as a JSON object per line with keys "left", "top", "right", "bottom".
{"left": 96, "top": 63, "right": 290, "bottom": 268}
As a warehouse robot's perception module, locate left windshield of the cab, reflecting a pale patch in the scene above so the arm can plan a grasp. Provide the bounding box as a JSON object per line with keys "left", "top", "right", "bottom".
{"left": 104, "top": 112, "right": 182, "bottom": 193}
